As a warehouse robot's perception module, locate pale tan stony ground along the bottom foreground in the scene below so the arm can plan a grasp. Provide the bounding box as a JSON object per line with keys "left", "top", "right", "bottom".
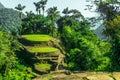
{"left": 33, "top": 72, "right": 120, "bottom": 80}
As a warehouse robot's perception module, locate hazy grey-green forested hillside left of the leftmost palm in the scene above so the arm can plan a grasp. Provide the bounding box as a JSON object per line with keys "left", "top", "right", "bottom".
{"left": 0, "top": 3, "right": 21, "bottom": 35}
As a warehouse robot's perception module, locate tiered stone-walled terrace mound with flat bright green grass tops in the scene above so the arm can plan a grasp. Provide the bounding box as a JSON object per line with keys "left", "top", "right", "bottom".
{"left": 21, "top": 34, "right": 64, "bottom": 73}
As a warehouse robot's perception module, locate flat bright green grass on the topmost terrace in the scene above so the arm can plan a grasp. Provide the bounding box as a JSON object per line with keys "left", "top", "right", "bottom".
{"left": 22, "top": 34, "right": 52, "bottom": 42}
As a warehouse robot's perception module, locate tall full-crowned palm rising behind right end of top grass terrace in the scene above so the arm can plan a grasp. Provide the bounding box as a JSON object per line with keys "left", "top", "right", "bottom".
{"left": 47, "top": 7, "right": 60, "bottom": 37}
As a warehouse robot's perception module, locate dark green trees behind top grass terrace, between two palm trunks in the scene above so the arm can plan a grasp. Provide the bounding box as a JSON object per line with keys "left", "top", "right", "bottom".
{"left": 22, "top": 12, "right": 51, "bottom": 34}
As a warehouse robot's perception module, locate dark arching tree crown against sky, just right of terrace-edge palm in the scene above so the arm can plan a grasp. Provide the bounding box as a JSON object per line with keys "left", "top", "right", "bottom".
{"left": 57, "top": 7, "right": 85, "bottom": 33}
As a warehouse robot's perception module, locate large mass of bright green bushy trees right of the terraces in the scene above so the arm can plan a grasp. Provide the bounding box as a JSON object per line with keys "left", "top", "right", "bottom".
{"left": 61, "top": 16, "right": 111, "bottom": 70}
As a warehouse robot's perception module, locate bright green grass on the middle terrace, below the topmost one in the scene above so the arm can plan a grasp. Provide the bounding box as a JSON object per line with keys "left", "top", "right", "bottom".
{"left": 27, "top": 47, "right": 58, "bottom": 53}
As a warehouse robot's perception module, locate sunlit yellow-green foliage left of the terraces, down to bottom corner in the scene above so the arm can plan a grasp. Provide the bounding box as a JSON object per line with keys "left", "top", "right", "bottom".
{"left": 0, "top": 31, "right": 32, "bottom": 80}
